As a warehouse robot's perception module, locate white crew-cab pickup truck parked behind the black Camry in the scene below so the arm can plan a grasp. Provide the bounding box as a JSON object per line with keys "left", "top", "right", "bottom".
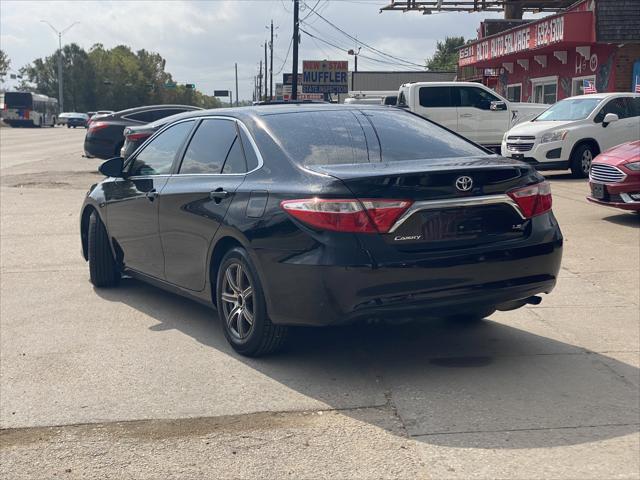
{"left": 397, "top": 82, "right": 549, "bottom": 152}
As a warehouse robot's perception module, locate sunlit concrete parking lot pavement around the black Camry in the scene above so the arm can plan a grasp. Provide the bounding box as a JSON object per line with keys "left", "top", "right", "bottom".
{"left": 0, "top": 128, "right": 640, "bottom": 479}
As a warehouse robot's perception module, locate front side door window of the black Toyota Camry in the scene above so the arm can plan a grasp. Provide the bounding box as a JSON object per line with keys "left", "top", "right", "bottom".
{"left": 129, "top": 121, "right": 194, "bottom": 176}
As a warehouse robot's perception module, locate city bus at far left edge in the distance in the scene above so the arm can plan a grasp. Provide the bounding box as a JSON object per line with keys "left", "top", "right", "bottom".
{"left": 0, "top": 92, "right": 58, "bottom": 127}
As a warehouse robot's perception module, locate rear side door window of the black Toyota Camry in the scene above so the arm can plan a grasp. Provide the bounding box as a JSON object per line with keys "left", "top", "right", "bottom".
{"left": 180, "top": 119, "right": 236, "bottom": 173}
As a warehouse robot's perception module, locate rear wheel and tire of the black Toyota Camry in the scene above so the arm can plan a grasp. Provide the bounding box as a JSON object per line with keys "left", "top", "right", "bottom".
{"left": 216, "top": 247, "right": 288, "bottom": 357}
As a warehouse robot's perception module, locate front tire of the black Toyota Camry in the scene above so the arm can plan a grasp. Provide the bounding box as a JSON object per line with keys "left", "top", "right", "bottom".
{"left": 87, "top": 212, "right": 121, "bottom": 288}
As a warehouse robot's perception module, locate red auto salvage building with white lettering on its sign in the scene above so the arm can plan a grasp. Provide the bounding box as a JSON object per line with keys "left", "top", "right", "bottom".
{"left": 458, "top": 0, "right": 640, "bottom": 103}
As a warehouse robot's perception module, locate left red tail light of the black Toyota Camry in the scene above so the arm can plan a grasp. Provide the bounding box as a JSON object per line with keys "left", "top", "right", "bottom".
{"left": 280, "top": 198, "right": 412, "bottom": 233}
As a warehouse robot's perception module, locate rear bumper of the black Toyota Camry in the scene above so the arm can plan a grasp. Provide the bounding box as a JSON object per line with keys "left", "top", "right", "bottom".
{"left": 260, "top": 215, "right": 562, "bottom": 325}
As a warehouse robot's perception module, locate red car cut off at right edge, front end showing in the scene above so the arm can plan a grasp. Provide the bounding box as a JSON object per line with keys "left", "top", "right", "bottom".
{"left": 587, "top": 140, "right": 640, "bottom": 213}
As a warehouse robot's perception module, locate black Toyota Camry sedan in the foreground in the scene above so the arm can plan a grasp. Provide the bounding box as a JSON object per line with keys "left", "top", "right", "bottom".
{"left": 81, "top": 105, "right": 563, "bottom": 355}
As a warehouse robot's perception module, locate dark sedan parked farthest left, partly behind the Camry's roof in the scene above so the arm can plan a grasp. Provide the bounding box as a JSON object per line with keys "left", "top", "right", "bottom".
{"left": 84, "top": 105, "right": 199, "bottom": 159}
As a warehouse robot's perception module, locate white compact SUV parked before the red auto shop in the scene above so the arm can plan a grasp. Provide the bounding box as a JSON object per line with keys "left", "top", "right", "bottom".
{"left": 502, "top": 93, "right": 640, "bottom": 178}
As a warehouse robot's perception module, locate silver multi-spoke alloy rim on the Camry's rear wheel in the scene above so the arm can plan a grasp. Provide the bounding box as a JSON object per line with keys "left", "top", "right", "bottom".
{"left": 221, "top": 262, "right": 254, "bottom": 340}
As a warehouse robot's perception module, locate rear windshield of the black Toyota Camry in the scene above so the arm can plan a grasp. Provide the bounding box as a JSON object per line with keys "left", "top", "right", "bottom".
{"left": 263, "top": 109, "right": 487, "bottom": 165}
